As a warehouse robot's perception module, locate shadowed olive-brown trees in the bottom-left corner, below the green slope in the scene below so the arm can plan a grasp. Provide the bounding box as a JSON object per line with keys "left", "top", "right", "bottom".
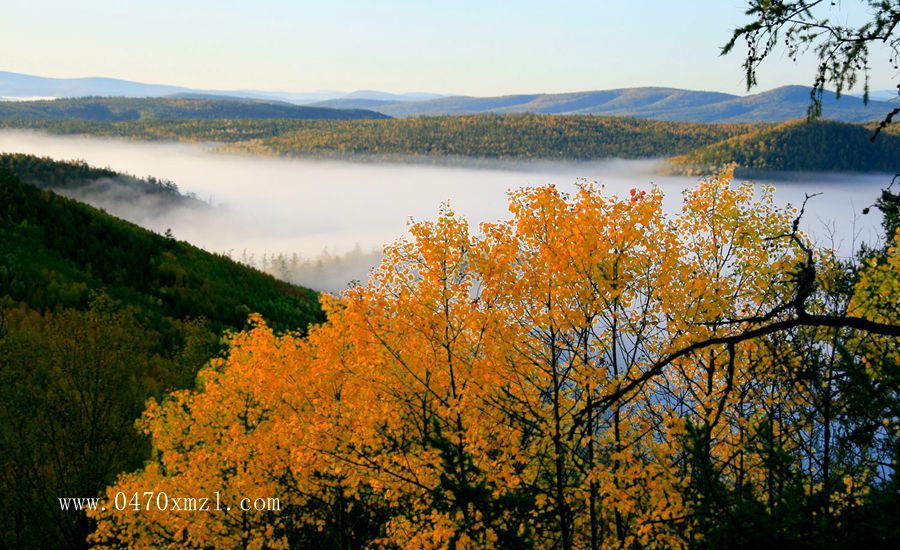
{"left": 0, "top": 294, "right": 210, "bottom": 548}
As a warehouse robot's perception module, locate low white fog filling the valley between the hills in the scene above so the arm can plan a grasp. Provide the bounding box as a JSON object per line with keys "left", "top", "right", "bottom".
{"left": 0, "top": 131, "right": 890, "bottom": 291}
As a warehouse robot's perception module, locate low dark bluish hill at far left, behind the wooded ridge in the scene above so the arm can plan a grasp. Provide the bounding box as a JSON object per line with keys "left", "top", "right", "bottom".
{"left": 0, "top": 97, "right": 387, "bottom": 122}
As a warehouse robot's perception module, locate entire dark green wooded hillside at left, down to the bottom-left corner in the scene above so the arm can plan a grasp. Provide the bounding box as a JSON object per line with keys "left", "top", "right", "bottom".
{"left": 0, "top": 166, "right": 323, "bottom": 548}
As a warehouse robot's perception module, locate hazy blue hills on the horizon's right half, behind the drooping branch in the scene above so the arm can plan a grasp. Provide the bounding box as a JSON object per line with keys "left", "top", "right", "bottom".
{"left": 356, "top": 86, "right": 893, "bottom": 123}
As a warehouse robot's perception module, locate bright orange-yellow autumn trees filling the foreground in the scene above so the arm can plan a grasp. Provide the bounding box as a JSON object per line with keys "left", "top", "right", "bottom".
{"left": 91, "top": 172, "right": 900, "bottom": 548}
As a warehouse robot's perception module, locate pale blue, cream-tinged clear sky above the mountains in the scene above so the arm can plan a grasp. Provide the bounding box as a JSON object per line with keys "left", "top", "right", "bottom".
{"left": 0, "top": 0, "right": 895, "bottom": 95}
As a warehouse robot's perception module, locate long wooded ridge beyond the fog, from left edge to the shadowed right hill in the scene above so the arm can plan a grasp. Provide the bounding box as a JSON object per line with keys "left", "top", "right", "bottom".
{"left": 0, "top": 115, "right": 755, "bottom": 160}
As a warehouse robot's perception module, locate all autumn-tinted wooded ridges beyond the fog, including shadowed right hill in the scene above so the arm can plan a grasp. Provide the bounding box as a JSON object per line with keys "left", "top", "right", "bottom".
{"left": 0, "top": 109, "right": 900, "bottom": 174}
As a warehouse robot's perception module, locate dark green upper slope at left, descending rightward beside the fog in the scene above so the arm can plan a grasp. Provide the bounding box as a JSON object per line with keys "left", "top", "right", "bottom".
{"left": 0, "top": 162, "right": 320, "bottom": 329}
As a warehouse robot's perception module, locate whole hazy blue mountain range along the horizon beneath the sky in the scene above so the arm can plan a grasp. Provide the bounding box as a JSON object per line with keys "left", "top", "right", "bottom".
{"left": 0, "top": 72, "right": 900, "bottom": 123}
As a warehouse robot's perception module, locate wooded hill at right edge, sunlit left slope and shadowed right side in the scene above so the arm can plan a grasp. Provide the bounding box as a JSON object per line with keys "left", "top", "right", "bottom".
{"left": 671, "top": 120, "right": 900, "bottom": 174}
